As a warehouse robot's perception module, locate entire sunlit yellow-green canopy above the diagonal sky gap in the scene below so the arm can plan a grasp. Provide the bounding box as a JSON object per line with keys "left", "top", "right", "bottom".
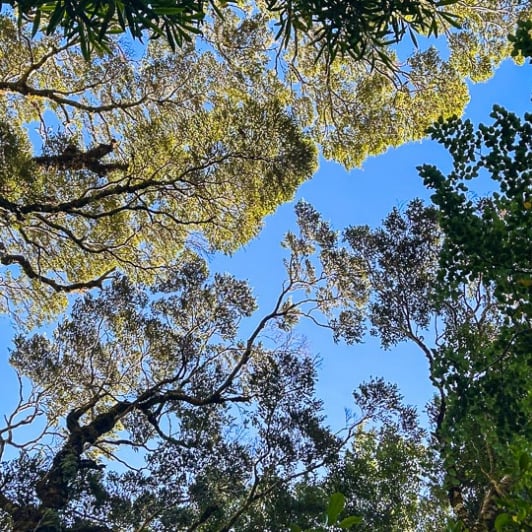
{"left": 0, "top": 3, "right": 529, "bottom": 323}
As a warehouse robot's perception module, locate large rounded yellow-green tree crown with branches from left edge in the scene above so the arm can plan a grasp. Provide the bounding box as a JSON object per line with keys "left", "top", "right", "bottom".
{"left": 0, "top": 15, "right": 316, "bottom": 324}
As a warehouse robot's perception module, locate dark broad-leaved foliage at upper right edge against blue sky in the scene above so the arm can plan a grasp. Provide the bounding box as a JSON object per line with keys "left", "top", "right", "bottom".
{"left": 420, "top": 106, "right": 532, "bottom": 323}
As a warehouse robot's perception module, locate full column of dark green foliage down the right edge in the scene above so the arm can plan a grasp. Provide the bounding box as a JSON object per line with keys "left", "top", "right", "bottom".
{"left": 420, "top": 110, "right": 532, "bottom": 530}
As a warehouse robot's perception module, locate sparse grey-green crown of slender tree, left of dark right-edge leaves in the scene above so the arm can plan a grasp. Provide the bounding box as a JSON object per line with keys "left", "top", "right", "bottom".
{"left": 345, "top": 200, "right": 441, "bottom": 348}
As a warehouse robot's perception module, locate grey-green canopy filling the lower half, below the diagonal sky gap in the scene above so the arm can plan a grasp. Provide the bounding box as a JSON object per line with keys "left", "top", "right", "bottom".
{"left": 0, "top": 183, "right": 531, "bottom": 531}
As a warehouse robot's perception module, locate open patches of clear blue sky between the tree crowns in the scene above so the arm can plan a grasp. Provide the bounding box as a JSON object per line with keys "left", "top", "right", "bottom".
{"left": 0, "top": 56, "right": 532, "bottom": 436}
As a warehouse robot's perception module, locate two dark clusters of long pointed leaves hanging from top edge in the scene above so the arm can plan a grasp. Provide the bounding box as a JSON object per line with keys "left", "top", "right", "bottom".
{"left": 9, "top": 0, "right": 459, "bottom": 61}
